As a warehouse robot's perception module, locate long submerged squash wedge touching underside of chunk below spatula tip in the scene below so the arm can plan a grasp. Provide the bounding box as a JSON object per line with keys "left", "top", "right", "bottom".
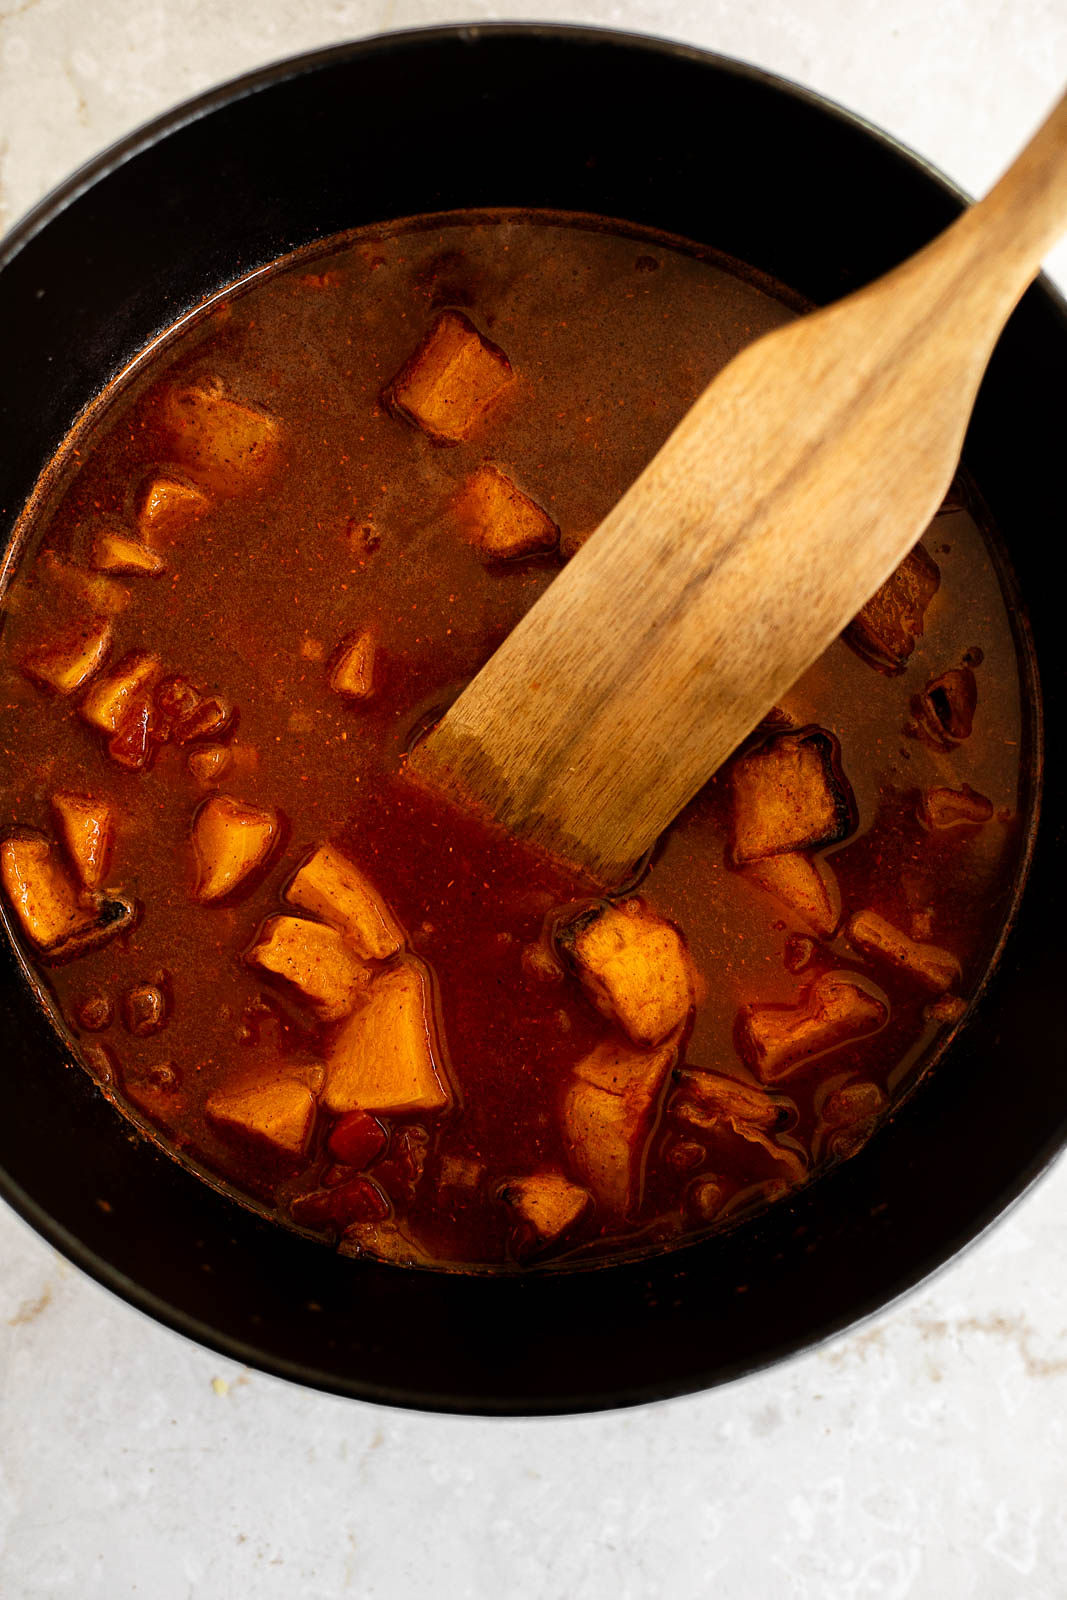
{"left": 563, "top": 1042, "right": 677, "bottom": 1216}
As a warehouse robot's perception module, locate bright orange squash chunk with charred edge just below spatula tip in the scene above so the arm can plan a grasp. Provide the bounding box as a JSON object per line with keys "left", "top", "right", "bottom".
{"left": 558, "top": 899, "right": 696, "bottom": 1045}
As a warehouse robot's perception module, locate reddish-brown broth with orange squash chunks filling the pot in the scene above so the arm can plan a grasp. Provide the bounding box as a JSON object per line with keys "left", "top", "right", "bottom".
{"left": 0, "top": 213, "right": 1022, "bottom": 1266}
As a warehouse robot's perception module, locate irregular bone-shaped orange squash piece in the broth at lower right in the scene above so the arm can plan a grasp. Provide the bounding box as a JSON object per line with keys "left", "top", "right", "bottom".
{"left": 737, "top": 973, "right": 889, "bottom": 1083}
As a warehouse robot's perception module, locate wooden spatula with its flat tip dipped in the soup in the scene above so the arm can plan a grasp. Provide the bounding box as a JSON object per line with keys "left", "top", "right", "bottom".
{"left": 413, "top": 87, "right": 1067, "bottom": 885}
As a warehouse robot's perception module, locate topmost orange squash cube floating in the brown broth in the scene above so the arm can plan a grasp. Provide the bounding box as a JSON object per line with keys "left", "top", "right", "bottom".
{"left": 382, "top": 310, "right": 514, "bottom": 445}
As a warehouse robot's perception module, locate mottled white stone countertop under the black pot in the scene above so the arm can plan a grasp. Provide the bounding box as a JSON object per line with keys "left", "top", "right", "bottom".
{"left": 0, "top": 0, "right": 1067, "bottom": 1600}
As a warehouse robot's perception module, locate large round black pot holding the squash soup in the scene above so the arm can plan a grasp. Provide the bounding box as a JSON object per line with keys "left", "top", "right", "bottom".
{"left": 0, "top": 18, "right": 1067, "bottom": 1413}
